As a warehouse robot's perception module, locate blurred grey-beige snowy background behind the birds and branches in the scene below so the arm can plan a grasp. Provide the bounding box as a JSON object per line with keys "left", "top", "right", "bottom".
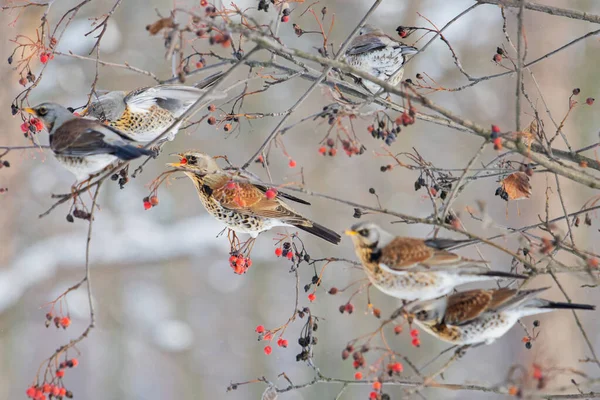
{"left": 0, "top": 0, "right": 600, "bottom": 400}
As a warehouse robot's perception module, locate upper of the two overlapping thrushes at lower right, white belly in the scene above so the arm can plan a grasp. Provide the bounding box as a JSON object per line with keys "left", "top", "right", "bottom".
{"left": 345, "top": 222, "right": 526, "bottom": 301}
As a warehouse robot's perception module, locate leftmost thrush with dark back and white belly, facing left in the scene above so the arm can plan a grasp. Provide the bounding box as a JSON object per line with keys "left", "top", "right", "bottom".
{"left": 23, "top": 102, "right": 156, "bottom": 181}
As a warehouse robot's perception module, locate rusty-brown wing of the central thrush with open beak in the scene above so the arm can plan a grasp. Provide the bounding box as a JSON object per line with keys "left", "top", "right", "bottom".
{"left": 203, "top": 178, "right": 307, "bottom": 225}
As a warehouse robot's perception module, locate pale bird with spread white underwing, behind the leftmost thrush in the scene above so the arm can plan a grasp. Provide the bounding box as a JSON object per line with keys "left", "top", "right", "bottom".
{"left": 81, "top": 72, "right": 225, "bottom": 143}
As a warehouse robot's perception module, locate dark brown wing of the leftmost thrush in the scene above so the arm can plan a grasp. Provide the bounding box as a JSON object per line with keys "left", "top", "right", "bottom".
{"left": 50, "top": 118, "right": 138, "bottom": 157}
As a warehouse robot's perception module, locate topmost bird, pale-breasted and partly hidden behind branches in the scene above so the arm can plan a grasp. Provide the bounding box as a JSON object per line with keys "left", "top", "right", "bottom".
{"left": 344, "top": 24, "right": 419, "bottom": 93}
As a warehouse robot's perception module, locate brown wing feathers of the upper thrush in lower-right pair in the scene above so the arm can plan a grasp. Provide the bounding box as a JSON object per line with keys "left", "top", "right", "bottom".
{"left": 379, "top": 237, "right": 461, "bottom": 270}
